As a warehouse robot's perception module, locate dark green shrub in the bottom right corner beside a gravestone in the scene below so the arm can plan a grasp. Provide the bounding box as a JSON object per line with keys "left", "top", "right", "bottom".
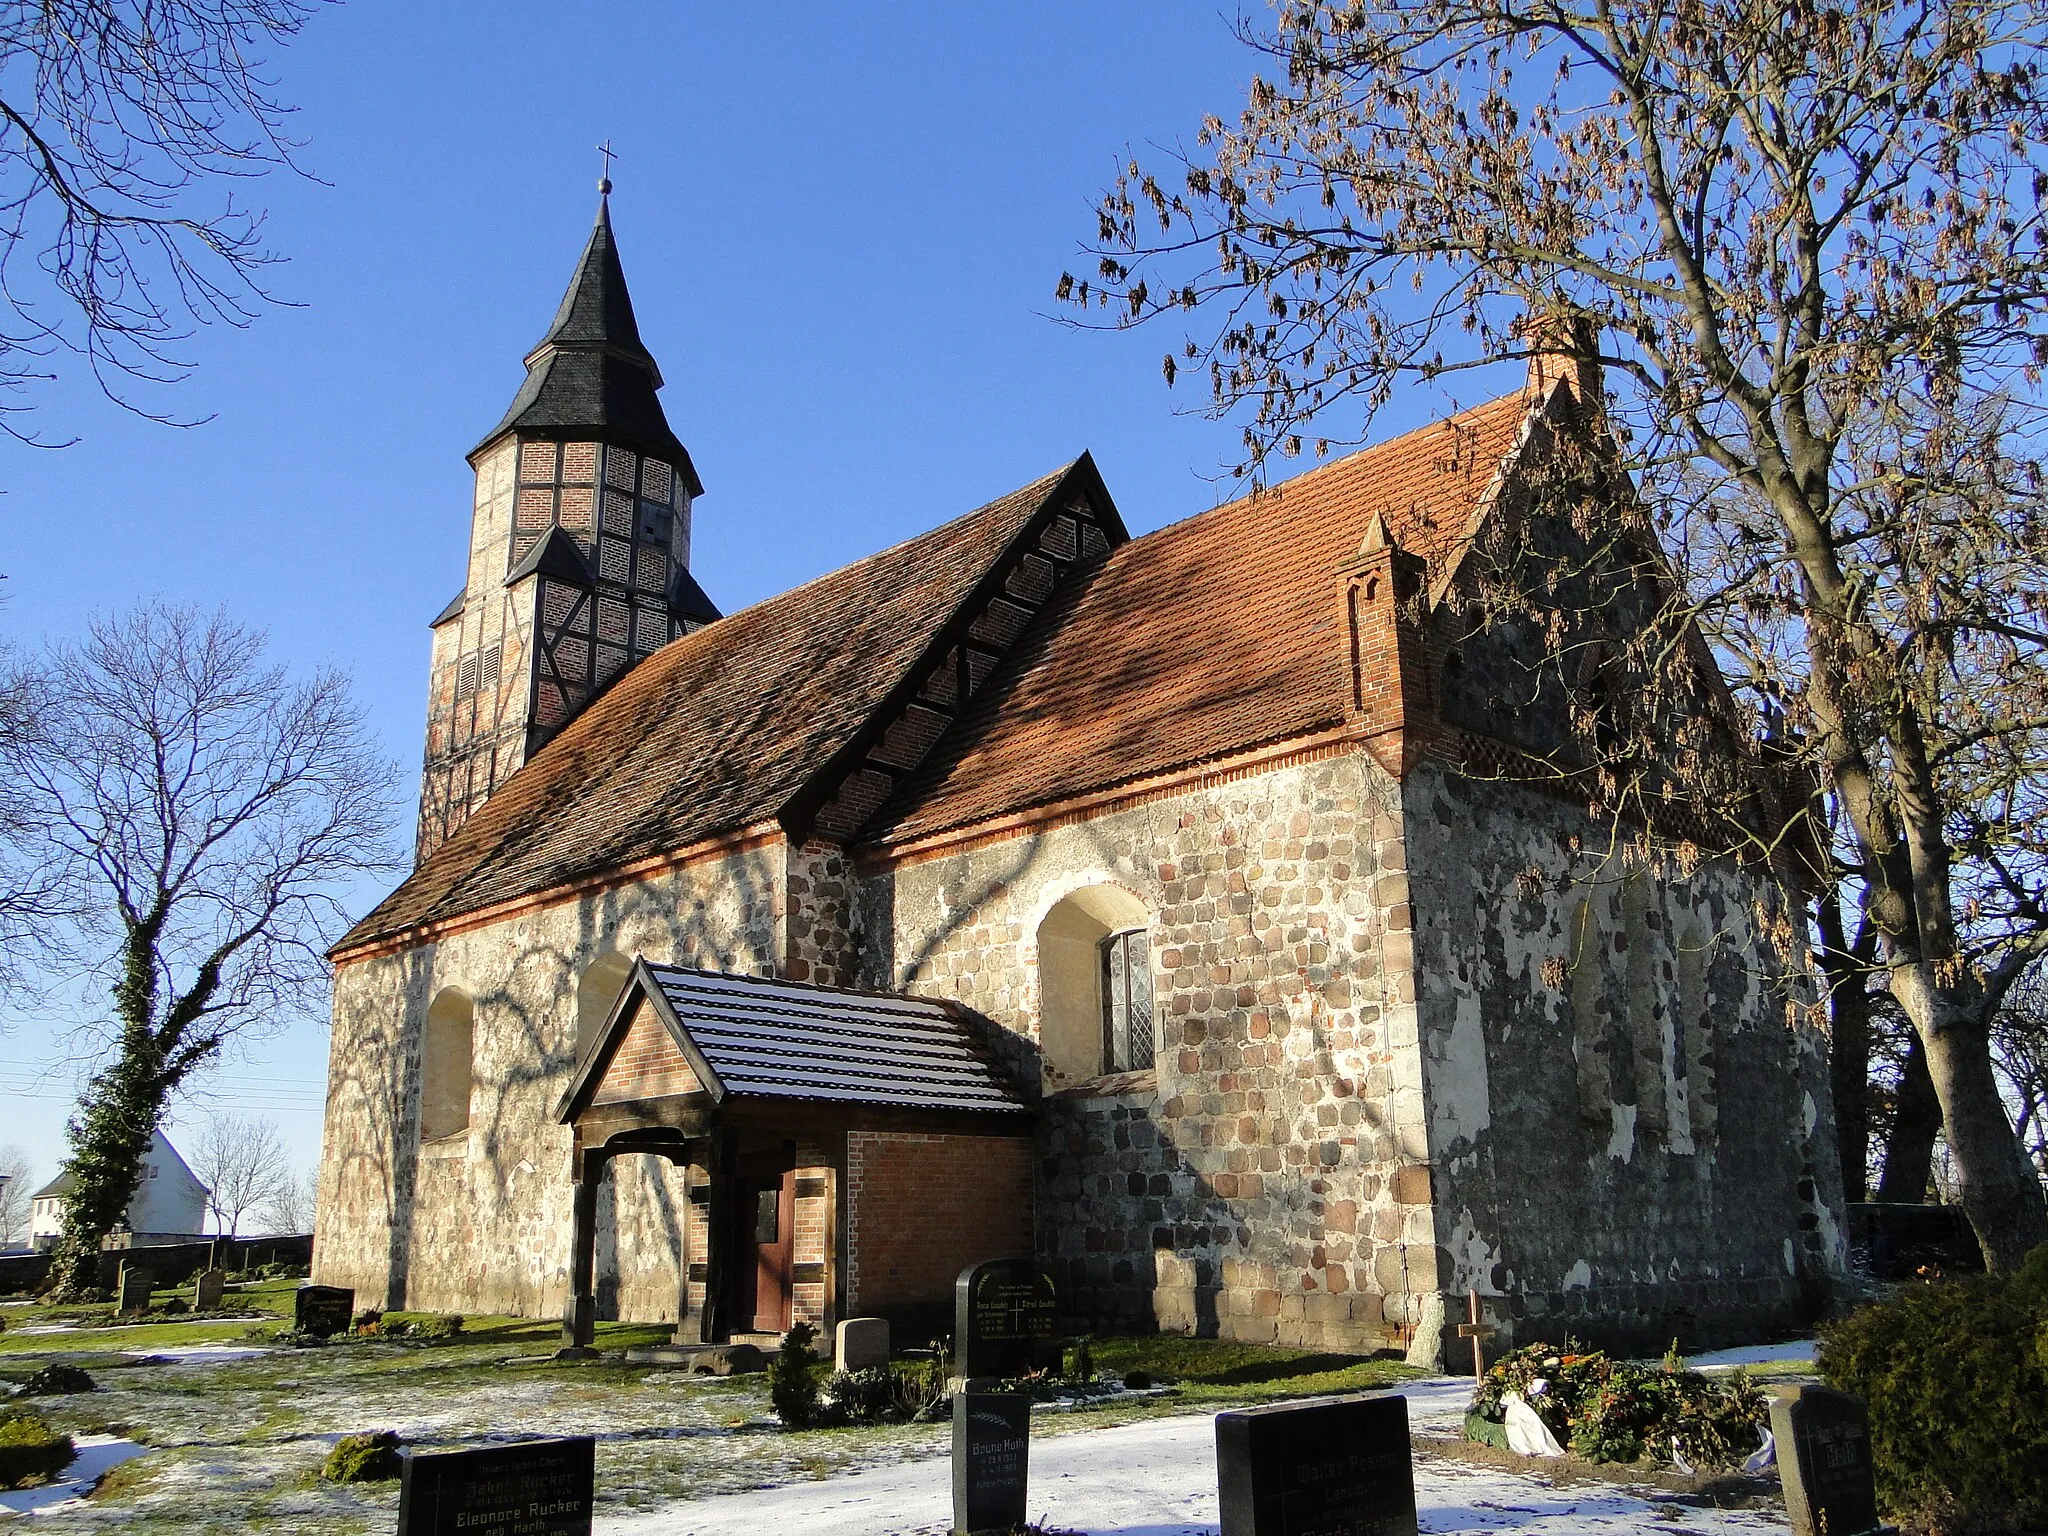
{"left": 1821, "top": 1247, "right": 2048, "bottom": 1532}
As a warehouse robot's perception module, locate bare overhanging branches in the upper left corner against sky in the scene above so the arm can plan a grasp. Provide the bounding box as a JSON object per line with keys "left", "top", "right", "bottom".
{"left": 0, "top": 0, "right": 311, "bottom": 436}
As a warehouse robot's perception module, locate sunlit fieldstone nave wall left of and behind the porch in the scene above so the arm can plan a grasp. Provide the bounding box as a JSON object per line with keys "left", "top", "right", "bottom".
{"left": 315, "top": 840, "right": 786, "bottom": 1321}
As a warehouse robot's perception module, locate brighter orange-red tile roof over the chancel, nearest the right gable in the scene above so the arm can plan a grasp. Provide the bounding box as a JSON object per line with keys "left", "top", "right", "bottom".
{"left": 864, "top": 395, "right": 1530, "bottom": 844}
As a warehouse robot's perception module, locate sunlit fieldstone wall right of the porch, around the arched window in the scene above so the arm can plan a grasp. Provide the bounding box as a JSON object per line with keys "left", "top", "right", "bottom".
{"left": 860, "top": 754, "right": 1436, "bottom": 1350}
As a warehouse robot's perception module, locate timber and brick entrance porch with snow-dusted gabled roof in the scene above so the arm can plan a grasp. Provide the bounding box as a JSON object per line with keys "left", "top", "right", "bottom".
{"left": 557, "top": 958, "right": 1034, "bottom": 1350}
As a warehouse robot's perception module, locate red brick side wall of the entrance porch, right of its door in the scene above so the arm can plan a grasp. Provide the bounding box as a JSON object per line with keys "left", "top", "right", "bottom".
{"left": 846, "top": 1130, "right": 1032, "bottom": 1315}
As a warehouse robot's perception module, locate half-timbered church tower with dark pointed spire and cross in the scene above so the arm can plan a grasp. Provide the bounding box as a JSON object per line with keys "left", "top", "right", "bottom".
{"left": 414, "top": 178, "right": 719, "bottom": 862}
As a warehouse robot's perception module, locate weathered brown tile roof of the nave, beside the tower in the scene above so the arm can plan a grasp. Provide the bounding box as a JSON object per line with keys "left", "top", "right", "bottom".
{"left": 336, "top": 465, "right": 1071, "bottom": 950}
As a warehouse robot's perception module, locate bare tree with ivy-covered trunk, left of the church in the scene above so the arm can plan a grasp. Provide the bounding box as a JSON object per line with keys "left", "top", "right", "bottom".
{"left": 0, "top": 604, "right": 397, "bottom": 1292}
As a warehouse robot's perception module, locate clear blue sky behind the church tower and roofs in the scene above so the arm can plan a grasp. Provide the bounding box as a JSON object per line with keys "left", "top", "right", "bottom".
{"left": 0, "top": 0, "right": 1482, "bottom": 1212}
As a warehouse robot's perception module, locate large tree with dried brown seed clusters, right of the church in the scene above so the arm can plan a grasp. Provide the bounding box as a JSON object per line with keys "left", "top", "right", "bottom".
{"left": 1061, "top": 0, "right": 2048, "bottom": 1268}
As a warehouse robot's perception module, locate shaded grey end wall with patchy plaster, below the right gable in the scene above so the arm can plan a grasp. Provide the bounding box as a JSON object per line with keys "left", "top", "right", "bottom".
{"left": 1403, "top": 762, "right": 1845, "bottom": 1354}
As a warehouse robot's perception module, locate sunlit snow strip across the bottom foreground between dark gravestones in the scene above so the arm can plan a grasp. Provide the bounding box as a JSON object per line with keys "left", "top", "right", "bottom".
{"left": 596, "top": 1376, "right": 1786, "bottom": 1536}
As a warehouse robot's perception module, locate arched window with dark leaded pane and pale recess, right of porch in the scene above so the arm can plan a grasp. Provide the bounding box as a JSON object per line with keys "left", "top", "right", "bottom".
{"left": 1038, "top": 885, "right": 1157, "bottom": 1087}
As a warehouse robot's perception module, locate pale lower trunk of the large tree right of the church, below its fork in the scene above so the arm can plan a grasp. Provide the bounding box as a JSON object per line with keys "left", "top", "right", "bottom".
{"left": 1892, "top": 965, "right": 2048, "bottom": 1274}
